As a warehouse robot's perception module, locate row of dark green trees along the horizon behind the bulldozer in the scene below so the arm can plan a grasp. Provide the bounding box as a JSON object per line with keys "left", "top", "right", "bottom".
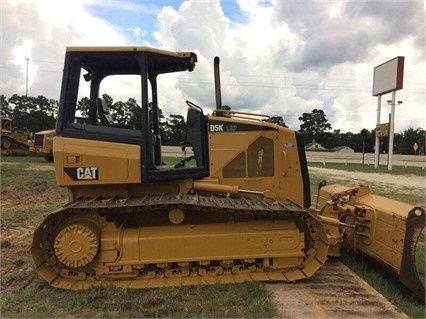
{"left": 0, "top": 94, "right": 426, "bottom": 155}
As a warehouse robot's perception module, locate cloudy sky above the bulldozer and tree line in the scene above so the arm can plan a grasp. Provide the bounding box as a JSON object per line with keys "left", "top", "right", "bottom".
{"left": 0, "top": 0, "right": 426, "bottom": 133}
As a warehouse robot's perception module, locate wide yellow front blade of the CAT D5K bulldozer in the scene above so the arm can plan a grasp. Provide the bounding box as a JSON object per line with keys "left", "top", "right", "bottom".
{"left": 317, "top": 183, "right": 425, "bottom": 302}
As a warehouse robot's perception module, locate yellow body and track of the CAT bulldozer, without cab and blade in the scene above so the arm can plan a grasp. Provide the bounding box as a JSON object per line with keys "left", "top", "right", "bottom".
{"left": 32, "top": 118, "right": 328, "bottom": 289}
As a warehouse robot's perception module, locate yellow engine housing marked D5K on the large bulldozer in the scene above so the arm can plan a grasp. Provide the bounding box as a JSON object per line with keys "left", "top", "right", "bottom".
{"left": 209, "top": 117, "right": 303, "bottom": 205}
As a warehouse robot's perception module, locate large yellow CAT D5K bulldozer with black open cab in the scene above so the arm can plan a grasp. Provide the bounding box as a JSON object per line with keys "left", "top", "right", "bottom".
{"left": 31, "top": 47, "right": 425, "bottom": 300}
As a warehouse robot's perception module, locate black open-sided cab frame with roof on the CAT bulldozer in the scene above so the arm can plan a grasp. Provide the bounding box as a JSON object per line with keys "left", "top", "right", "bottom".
{"left": 56, "top": 47, "right": 209, "bottom": 182}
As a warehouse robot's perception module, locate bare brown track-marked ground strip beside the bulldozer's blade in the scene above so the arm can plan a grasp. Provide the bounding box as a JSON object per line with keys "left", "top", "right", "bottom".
{"left": 266, "top": 260, "right": 408, "bottom": 319}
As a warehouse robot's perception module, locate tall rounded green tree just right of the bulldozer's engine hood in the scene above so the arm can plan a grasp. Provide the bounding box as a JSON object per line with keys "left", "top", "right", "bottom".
{"left": 299, "top": 109, "right": 331, "bottom": 143}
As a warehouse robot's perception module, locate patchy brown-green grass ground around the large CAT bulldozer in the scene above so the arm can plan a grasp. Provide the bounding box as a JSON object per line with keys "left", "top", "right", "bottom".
{"left": 0, "top": 157, "right": 425, "bottom": 318}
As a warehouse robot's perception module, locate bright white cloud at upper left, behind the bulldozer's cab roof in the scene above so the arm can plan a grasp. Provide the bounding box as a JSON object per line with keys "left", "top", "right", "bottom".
{"left": 0, "top": 0, "right": 125, "bottom": 99}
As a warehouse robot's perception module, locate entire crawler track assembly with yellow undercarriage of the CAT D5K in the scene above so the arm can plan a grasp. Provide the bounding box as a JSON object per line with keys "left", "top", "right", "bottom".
{"left": 31, "top": 194, "right": 328, "bottom": 290}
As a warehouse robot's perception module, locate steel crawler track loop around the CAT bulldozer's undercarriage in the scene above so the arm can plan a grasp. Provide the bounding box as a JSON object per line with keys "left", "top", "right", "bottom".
{"left": 31, "top": 194, "right": 328, "bottom": 290}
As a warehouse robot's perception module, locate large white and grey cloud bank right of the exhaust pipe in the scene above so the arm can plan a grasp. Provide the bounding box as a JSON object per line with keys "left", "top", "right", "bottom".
{"left": 152, "top": 1, "right": 426, "bottom": 132}
